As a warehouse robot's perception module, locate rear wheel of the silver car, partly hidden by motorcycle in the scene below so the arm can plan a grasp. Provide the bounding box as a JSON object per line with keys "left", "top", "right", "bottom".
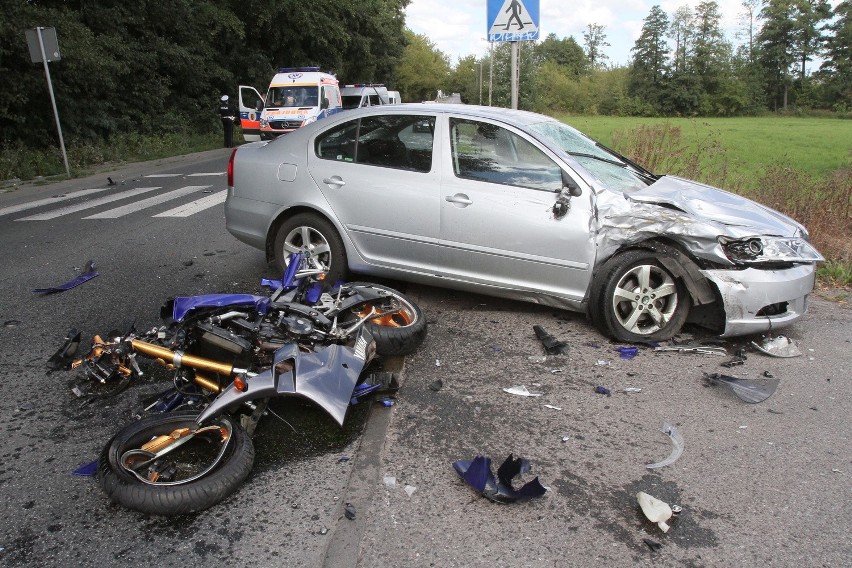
{"left": 273, "top": 213, "right": 348, "bottom": 284}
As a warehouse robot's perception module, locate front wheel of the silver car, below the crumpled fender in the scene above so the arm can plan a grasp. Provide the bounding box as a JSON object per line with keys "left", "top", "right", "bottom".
{"left": 589, "top": 250, "right": 691, "bottom": 343}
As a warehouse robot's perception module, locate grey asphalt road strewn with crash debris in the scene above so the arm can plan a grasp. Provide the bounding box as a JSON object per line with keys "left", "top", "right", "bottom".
{"left": 0, "top": 149, "right": 852, "bottom": 568}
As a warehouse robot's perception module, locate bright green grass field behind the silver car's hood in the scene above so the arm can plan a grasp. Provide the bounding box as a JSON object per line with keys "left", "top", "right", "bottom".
{"left": 556, "top": 116, "right": 852, "bottom": 184}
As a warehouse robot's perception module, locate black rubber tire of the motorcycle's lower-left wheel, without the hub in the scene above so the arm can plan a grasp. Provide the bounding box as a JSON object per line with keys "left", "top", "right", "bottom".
{"left": 98, "top": 411, "right": 254, "bottom": 516}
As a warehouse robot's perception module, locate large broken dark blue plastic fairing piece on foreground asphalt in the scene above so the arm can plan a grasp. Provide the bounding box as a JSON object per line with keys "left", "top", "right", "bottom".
{"left": 453, "top": 454, "right": 547, "bottom": 503}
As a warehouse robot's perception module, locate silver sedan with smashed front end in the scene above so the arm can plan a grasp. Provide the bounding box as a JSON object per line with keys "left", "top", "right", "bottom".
{"left": 225, "top": 104, "right": 823, "bottom": 341}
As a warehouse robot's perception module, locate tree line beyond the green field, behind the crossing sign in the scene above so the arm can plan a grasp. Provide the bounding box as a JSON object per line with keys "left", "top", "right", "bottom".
{"left": 397, "top": 0, "right": 852, "bottom": 116}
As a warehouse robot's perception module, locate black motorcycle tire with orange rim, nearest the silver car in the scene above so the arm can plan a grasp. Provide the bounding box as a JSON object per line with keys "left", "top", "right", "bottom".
{"left": 347, "top": 282, "right": 426, "bottom": 357}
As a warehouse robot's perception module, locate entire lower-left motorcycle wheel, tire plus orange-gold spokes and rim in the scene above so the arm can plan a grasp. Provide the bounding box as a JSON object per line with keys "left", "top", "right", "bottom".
{"left": 98, "top": 412, "right": 254, "bottom": 516}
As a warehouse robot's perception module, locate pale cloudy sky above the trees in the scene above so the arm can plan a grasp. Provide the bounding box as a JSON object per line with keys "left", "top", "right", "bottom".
{"left": 405, "top": 0, "right": 839, "bottom": 65}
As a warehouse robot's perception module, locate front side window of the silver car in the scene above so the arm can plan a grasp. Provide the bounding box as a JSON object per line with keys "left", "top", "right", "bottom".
{"left": 450, "top": 118, "right": 562, "bottom": 192}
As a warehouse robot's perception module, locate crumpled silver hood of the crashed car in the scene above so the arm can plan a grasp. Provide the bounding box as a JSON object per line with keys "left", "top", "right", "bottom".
{"left": 625, "top": 176, "right": 804, "bottom": 237}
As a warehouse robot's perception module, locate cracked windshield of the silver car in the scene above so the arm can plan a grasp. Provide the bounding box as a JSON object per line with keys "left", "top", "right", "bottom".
{"left": 529, "top": 121, "right": 656, "bottom": 192}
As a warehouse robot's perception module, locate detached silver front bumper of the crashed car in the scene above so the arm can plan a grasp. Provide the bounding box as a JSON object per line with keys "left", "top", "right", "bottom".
{"left": 701, "top": 264, "right": 816, "bottom": 337}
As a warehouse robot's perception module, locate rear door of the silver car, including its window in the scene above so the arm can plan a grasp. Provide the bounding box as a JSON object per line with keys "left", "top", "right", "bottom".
{"left": 308, "top": 113, "right": 440, "bottom": 273}
